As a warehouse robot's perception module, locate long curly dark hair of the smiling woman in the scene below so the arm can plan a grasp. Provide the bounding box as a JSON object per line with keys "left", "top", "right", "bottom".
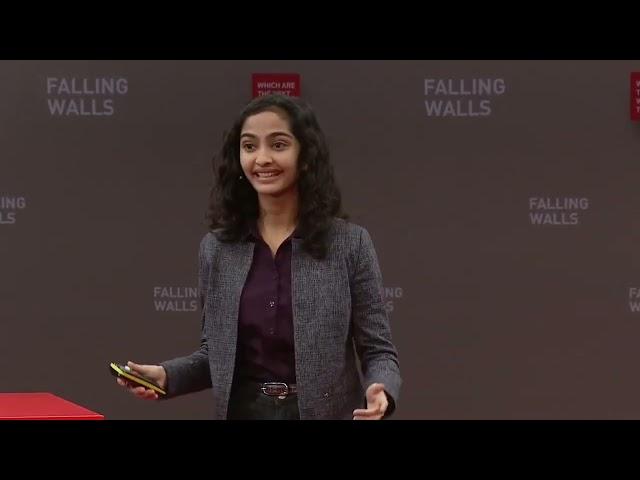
{"left": 207, "top": 94, "right": 347, "bottom": 259}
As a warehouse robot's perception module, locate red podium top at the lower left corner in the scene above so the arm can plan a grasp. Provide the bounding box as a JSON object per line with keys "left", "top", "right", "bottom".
{"left": 0, "top": 393, "right": 104, "bottom": 420}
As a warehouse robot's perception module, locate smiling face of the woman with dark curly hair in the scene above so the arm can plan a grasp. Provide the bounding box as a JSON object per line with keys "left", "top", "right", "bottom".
{"left": 240, "top": 108, "right": 300, "bottom": 196}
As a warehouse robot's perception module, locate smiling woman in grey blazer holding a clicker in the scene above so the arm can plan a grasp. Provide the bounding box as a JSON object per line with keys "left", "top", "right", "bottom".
{"left": 118, "top": 95, "right": 401, "bottom": 420}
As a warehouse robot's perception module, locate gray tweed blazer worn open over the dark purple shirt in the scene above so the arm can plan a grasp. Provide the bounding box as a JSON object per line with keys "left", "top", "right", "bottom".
{"left": 161, "top": 219, "right": 402, "bottom": 420}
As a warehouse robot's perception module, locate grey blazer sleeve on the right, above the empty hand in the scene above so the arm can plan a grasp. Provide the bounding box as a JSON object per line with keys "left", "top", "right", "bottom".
{"left": 351, "top": 228, "right": 402, "bottom": 416}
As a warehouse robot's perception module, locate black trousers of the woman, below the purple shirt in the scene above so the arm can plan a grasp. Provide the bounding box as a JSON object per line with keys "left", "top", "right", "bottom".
{"left": 227, "top": 381, "right": 300, "bottom": 420}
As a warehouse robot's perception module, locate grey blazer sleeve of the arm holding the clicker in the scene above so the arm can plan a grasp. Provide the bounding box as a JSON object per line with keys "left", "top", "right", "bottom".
{"left": 160, "top": 233, "right": 216, "bottom": 398}
